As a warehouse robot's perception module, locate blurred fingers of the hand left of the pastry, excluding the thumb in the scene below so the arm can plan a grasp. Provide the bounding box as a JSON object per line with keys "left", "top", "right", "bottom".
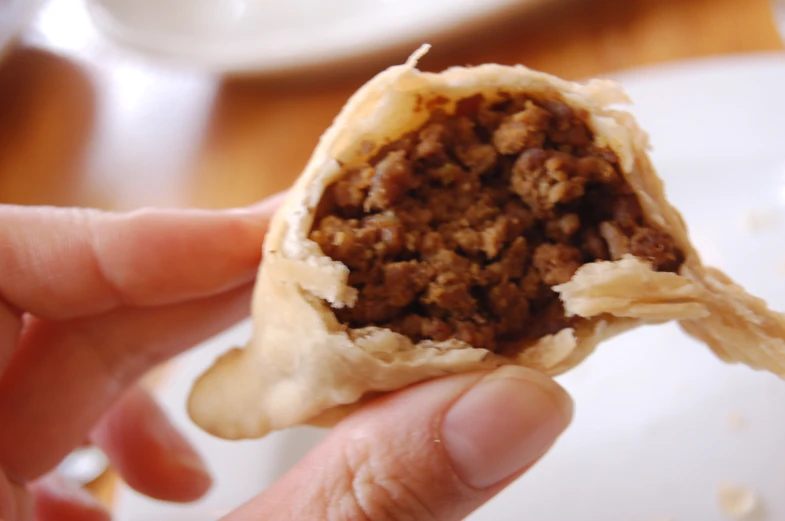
{"left": 0, "top": 193, "right": 277, "bottom": 521}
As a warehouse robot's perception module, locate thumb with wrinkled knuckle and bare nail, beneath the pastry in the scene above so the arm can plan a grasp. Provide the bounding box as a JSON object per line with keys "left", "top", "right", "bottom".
{"left": 225, "top": 367, "right": 572, "bottom": 521}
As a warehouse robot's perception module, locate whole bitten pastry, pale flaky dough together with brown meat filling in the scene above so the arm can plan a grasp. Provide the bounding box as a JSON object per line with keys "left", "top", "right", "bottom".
{"left": 189, "top": 47, "right": 785, "bottom": 439}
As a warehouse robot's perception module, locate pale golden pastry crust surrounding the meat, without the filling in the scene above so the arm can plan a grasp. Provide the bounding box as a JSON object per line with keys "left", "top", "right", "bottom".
{"left": 188, "top": 50, "right": 785, "bottom": 439}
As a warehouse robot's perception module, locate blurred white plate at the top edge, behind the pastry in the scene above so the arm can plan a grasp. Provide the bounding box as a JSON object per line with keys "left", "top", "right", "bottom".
{"left": 82, "top": 0, "right": 541, "bottom": 72}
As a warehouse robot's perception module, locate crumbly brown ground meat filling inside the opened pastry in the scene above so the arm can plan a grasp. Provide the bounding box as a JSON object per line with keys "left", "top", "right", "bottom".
{"left": 310, "top": 93, "right": 683, "bottom": 352}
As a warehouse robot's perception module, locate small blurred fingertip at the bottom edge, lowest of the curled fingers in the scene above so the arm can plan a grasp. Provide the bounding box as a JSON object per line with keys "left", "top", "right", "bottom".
{"left": 30, "top": 474, "right": 111, "bottom": 521}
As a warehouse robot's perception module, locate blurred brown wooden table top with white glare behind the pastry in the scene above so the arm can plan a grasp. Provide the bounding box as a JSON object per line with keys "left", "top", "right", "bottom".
{"left": 0, "top": 0, "right": 782, "bottom": 508}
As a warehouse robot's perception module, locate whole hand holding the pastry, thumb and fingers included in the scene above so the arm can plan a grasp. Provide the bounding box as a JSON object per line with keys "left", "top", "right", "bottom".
{"left": 0, "top": 193, "right": 572, "bottom": 521}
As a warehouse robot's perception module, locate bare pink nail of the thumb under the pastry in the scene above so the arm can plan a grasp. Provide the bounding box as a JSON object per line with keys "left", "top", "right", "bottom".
{"left": 441, "top": 366, "right": 572, "bottom": 489}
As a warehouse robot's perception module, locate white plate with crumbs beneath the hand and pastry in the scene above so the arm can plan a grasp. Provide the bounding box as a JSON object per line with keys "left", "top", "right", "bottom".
{"left": 113, "top": 55, "right": 785, "bottom": 521}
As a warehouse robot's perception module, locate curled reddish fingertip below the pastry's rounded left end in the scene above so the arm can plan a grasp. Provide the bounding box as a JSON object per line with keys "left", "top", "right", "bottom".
{"left": 91, "top": 386, "right": 212, "bottom": 502}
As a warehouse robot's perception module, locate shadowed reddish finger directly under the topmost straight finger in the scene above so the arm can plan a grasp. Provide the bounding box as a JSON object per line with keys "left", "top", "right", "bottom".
{"left": 0, "top": 285, "right": 252, "bottom": 482}
